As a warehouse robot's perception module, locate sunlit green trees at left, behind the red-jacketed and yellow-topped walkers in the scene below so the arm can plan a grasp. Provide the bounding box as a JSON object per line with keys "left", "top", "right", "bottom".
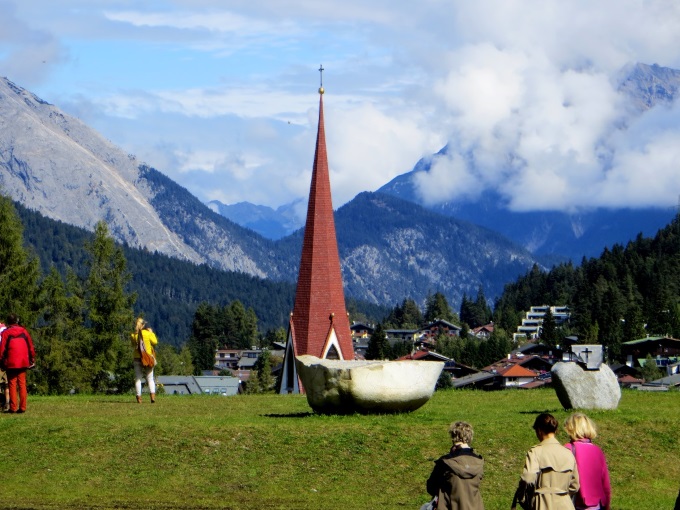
{"left": 0, "top": 197, "right": 258, "bottom": 394}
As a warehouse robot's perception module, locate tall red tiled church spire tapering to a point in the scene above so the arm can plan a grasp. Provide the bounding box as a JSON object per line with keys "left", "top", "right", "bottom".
{"left": 291, "top": 87, "right": 354, "bottom": 360}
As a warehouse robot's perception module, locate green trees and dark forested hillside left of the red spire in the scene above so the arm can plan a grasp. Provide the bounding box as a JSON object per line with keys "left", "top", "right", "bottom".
{"left": 0, "top": 196, "right": 385, "bottom": 394}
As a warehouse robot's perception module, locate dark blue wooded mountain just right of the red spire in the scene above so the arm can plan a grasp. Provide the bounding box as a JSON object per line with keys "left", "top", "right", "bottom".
{"left": 279, "top": 192, "right": 537, "bottom": 302}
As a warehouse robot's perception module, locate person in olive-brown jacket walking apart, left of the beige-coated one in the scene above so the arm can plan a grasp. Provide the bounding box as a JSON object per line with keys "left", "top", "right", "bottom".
{"left": 427, "top": 421, "right": 484, "bottom": 510}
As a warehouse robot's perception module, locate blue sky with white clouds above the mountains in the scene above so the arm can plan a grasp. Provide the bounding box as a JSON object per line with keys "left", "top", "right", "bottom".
{"left": 0, "top": 0, "right": 680, "bottom": 219}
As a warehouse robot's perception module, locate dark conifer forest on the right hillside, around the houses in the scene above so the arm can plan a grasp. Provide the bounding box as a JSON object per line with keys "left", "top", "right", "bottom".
{"left": 367, "top": 214, "right": 680, "bottom": 368}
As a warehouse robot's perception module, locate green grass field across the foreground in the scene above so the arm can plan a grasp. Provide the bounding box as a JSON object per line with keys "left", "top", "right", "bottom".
{"left": 0, "top": 389, "right": 680, "bottom": 510}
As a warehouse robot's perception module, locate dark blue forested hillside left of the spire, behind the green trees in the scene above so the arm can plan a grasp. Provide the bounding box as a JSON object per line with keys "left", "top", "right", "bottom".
{"left": 15, "top": 203, "right": 387, "bottom": 346}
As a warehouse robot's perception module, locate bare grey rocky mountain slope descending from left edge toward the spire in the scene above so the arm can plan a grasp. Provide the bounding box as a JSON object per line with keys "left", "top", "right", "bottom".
{"left": 0, "top": 78, "right": 295, "bottom": 280}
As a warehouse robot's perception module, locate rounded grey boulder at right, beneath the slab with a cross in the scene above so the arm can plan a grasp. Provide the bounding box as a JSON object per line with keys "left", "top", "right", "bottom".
{"left": 551, "top": 362, "right": 621, "bottom": 409}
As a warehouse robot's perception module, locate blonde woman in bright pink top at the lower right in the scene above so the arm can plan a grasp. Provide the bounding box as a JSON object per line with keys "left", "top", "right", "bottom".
{"left": 564, "top": 413, "right": 612, "bottom": 510}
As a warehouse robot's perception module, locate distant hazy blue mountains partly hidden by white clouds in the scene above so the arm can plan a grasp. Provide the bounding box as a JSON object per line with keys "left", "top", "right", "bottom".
{"left": 213, "top": 64, "right": 680, "bottom": 265}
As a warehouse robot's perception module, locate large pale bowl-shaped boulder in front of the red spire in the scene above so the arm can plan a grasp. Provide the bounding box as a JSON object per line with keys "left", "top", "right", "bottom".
{"left": 295, "top": 355, "right": 444, "bottom": 414}
